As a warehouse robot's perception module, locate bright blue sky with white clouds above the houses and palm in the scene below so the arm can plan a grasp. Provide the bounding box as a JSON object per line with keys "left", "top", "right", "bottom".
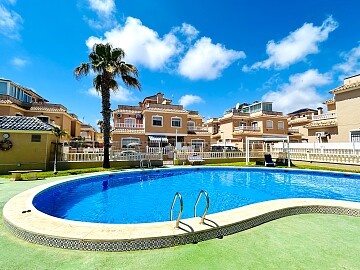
{"left": 0, "top": 0, "right": 360, "bottom": 129}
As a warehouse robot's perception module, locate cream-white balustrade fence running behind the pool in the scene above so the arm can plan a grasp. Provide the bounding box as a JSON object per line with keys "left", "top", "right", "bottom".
{"left": 62, "top": 143, "right": 360, "bottom": 165}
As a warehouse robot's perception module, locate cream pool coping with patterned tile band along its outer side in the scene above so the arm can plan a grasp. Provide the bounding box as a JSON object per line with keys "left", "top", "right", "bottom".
{"left": 3, "top": 167, "right": 360, "bottom": 251}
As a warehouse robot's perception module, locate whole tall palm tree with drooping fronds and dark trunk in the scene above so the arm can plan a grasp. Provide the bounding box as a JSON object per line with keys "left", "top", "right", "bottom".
{"left": 74, "top": 43, "right": 141, "bottom": 168}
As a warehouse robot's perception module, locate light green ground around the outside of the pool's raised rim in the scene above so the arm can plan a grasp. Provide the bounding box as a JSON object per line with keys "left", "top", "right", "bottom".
{"left": 0, "top": 164, "right": 360, "bottom": 270}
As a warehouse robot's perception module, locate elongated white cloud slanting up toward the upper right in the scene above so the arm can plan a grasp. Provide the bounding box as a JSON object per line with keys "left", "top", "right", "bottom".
{"left": 243, "top": 16, "right": 338, "bottom": 71}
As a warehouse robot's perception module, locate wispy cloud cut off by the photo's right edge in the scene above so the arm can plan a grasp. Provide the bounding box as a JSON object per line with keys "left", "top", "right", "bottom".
{"left": 334, "top": 45, "right": 360, "bottom": 80}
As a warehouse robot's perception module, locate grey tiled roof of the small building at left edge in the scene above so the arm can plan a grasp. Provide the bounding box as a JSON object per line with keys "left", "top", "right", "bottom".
{"left": 0, "top": 116, "right": 54, "bottom": 131}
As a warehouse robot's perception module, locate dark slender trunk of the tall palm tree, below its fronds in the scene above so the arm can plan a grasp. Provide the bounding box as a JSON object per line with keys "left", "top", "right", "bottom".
{"left": 101, "top": 87, "right": 111, "bottom": 168}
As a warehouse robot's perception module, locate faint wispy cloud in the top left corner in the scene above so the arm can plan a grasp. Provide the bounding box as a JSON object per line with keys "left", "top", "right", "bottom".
{"left": 0, "top": 5, "right": 23, "bottom": 39}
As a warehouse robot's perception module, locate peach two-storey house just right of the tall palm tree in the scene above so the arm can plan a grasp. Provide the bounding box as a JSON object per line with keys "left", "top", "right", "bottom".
{"left": 112, "top": 93, "right": 210, "bottom": 154}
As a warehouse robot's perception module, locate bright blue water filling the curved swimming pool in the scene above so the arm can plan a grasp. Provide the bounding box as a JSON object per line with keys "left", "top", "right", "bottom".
{"left": 33, "top": 167, "right": 360, "bottom": 224}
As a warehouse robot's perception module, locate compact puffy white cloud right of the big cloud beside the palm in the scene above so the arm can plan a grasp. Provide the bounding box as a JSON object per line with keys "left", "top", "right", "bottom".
{"left": 178, "top": 37, "right": 246, "bottom": 80}
